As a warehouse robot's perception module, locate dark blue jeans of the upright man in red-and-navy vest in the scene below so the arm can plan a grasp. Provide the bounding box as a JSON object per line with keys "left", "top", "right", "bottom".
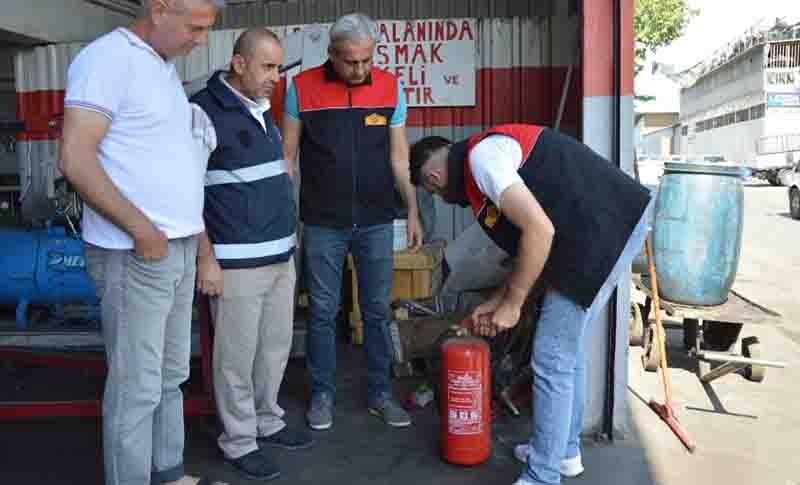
{"left": 303, "top": 224, "right": 394, "bottom": 403}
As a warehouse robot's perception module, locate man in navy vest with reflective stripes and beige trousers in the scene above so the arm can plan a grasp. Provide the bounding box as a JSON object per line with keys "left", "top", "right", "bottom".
{"left": 191, "top": 28, "right": 312, "bottom": 480}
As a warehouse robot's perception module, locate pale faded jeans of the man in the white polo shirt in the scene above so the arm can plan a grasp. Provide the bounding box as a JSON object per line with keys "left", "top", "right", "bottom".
{"left": 86, "top": 237, "right": 197, "bottom": 485}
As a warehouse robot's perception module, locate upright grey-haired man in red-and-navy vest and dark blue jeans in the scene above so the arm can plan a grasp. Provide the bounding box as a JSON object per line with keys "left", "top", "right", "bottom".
{"left": 284, "top": 13, "right": 422, "bottom": 430}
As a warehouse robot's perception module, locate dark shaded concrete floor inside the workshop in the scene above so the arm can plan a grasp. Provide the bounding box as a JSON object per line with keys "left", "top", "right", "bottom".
{"left": 0, "top": 343, "right": 655, "bottom": 485}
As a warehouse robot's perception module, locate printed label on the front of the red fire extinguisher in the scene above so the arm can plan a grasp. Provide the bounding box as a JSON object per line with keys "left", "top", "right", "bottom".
{"left": 447, "top": 371, "right": 481, "bottom": 435}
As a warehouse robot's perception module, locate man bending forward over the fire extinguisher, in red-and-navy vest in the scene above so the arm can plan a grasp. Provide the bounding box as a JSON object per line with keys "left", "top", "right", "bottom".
{"left": 411, "top": 125, "right": 650, "bottom": 485}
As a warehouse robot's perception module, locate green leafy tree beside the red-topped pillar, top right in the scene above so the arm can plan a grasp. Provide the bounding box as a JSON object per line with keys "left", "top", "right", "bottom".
{"left": 633, "top": 0, "right": 700, "bottom": 74}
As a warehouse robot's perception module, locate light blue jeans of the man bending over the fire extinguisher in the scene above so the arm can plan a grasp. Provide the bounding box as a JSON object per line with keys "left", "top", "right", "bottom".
{"left": 521, "top": 202, "right": 653, "bottom": 484}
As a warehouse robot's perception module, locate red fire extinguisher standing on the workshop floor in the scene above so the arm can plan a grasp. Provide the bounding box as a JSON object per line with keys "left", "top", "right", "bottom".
{"left": 439, "top": 324, "right": 492, "bottom": 465}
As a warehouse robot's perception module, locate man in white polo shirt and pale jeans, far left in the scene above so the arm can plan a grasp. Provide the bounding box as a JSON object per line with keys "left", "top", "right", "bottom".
{"left": 59, "top": 0, "right": 225, "bottom": 485}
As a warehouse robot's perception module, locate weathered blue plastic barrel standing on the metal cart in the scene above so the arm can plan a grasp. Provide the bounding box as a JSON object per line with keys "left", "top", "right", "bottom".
{"left": 653, "top": 163, "right": 747, "bottom": 305}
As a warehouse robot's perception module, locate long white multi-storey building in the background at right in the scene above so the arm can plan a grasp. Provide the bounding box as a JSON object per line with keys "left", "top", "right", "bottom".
{"left": 679, "top": 19, "right": 800, "bottom": 185}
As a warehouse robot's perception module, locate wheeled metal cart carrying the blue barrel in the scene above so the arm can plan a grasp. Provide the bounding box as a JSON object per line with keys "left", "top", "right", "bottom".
{"left": 630, "top": 275, "right": 786, "bottom": 382}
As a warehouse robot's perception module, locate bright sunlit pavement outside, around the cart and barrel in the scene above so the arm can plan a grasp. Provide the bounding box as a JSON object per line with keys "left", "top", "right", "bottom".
{"left": 624, "top": 184, "right": 800, "bottom": 485}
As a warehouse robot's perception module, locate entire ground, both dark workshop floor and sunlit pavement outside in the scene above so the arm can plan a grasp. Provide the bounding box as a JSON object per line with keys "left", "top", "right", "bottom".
{"left": 0, "top": 186, "right": 800, "bottom": 485}
